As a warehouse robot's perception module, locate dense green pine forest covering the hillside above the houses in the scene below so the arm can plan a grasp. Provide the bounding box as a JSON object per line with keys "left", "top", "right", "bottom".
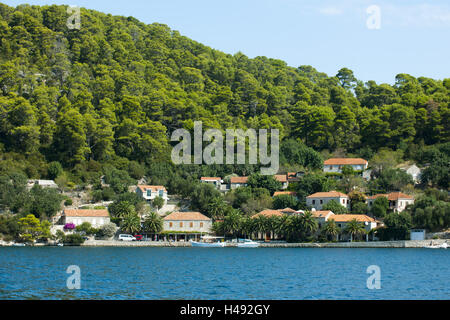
{"left": 0, "top": 4, "right": 450, "bottom": 188}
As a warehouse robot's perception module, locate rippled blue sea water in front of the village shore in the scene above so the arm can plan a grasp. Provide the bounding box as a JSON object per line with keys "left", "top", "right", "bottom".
{"left": 0, "top": 247, "right": 450, "bottom": 300}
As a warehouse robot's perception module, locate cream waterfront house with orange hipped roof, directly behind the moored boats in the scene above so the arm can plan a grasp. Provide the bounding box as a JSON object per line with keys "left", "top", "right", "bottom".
{"left": 164, "top": 212, "right": 212, "bottom": 233}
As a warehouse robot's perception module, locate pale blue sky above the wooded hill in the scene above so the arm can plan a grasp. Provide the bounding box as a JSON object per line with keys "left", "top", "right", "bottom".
{"left": 2, "top": 0, "right": 450, "bottom": 84}
